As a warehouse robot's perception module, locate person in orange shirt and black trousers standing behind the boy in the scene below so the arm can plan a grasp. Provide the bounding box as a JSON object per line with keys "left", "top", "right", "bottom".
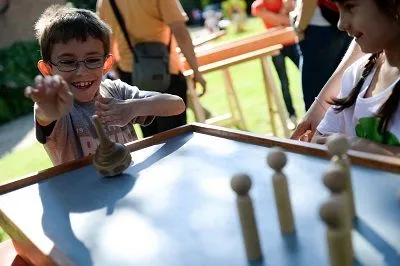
{"left": 97, "top": 0, "right": 206, "bottom": 137}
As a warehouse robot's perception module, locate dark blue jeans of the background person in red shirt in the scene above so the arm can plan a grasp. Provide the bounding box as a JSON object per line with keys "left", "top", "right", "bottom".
{"left": 272, "top": 44, "right": 301, "bottom": 116}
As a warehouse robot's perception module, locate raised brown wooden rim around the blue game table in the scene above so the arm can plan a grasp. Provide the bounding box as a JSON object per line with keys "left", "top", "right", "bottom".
{"left": 0, "top": 123, "right": 400, "bottom": 261}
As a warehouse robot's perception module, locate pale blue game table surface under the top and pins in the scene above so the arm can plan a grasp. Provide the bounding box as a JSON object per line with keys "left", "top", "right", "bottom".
{"left": 0, "top": 133, "right": 400, "bottom": 266}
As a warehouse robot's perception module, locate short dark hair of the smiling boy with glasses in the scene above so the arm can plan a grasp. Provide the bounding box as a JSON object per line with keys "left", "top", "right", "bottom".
{"left": 35, "top": 5, "right": 111, "bottom": 62}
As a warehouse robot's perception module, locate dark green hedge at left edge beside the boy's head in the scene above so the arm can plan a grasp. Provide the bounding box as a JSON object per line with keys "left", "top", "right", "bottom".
{"left": 0, "top": 41, "right": 40, "bottom": 124}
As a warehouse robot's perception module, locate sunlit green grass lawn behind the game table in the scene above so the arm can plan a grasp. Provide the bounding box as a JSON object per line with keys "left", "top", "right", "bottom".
{"left": 0, "top": 18, "right": 304, "bottom": 242}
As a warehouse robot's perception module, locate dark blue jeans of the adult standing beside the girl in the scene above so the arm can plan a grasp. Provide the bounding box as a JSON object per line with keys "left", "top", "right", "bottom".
{"left": 300, "top": 26, "right": 351, "bottom": 110}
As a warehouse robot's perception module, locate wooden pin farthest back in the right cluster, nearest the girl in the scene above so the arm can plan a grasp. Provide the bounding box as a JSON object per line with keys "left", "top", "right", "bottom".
{"left": 327, "top": 134, "right": 356, "bottom": 221}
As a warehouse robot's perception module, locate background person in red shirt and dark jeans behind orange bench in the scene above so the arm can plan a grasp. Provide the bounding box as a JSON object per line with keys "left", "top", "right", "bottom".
{"left": 251, "top": 0, "right": 301, "bottom": 129}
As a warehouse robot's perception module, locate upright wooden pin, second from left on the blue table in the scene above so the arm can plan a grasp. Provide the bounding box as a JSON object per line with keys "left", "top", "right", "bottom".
{"left": 267, "top": 148, "right": 295, "bottom": 234}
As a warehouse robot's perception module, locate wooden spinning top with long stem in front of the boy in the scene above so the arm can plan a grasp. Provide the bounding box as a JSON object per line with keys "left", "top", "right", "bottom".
{"left": 92, "top": 115, "right": 132, "bottom": 177}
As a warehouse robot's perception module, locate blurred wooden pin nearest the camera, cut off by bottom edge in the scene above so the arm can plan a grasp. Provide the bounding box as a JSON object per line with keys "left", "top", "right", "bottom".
{"left": 319, "top": 198, "right": 353, "bottom": 266}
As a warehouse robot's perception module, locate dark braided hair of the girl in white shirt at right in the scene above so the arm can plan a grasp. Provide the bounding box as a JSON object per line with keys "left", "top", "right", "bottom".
{"left": 328, "top": 0, "right": 400, "bottom": 143}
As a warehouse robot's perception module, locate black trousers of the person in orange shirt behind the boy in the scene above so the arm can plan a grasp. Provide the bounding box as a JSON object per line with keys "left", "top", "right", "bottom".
{"left": 141, "top": 74, "right": 187, "bottom": 137}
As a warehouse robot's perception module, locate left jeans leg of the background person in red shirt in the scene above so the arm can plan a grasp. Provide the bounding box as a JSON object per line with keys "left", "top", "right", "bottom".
{"left": 272, "top": 53, "right": 296, "bottom": 116}
